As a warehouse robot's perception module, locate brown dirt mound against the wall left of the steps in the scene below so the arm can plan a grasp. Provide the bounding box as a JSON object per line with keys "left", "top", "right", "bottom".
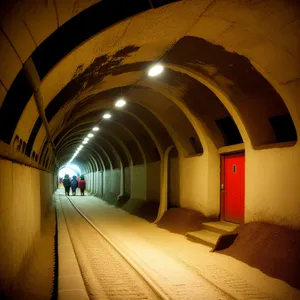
{"left": 156, "top": 207, "right": 215, "bottom": 235}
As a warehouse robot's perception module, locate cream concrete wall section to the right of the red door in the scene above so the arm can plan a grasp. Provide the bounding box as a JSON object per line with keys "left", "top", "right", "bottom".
{"left": 245, "top": 145, "right": 300, "bottom": 227}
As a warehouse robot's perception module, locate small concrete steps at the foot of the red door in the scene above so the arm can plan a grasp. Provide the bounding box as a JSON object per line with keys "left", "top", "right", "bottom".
{"left": 185, "top": 221, "right": 239, "bottom": 248}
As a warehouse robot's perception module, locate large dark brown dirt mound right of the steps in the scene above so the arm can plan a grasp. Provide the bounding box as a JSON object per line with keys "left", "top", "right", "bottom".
{"left": 217, "top": 222, "right": 300, "bottom": 289}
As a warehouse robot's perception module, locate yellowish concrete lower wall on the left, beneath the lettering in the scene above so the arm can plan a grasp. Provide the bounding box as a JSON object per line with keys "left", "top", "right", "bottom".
{"left": 0, "top": 159, "right": 53, "bottom": 290}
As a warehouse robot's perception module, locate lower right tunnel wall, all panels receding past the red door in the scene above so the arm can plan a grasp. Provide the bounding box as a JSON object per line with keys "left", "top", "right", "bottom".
{"left": 81, "top": 144, "right": 300, "bottom": 227}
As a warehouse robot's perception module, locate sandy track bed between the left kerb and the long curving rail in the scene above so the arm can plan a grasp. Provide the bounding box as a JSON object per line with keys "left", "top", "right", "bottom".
{"left": 61, "top": 196, "right": 171, "bottom": 300}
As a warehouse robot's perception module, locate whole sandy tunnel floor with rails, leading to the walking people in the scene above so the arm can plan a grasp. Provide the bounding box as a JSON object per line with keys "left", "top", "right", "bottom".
{"left": 56, "top": 189, "right": 300, "bottom": 299}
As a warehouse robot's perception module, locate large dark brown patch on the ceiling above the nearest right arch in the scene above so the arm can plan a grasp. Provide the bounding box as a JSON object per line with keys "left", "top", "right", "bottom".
{"left": 166, "top": 36, "right": 295, "bottom": 146}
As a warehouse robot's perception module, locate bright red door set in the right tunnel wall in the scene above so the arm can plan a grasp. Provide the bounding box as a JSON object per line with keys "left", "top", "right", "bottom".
{"left": 221, "top": 153, "right": 245, "bottom": 223}
